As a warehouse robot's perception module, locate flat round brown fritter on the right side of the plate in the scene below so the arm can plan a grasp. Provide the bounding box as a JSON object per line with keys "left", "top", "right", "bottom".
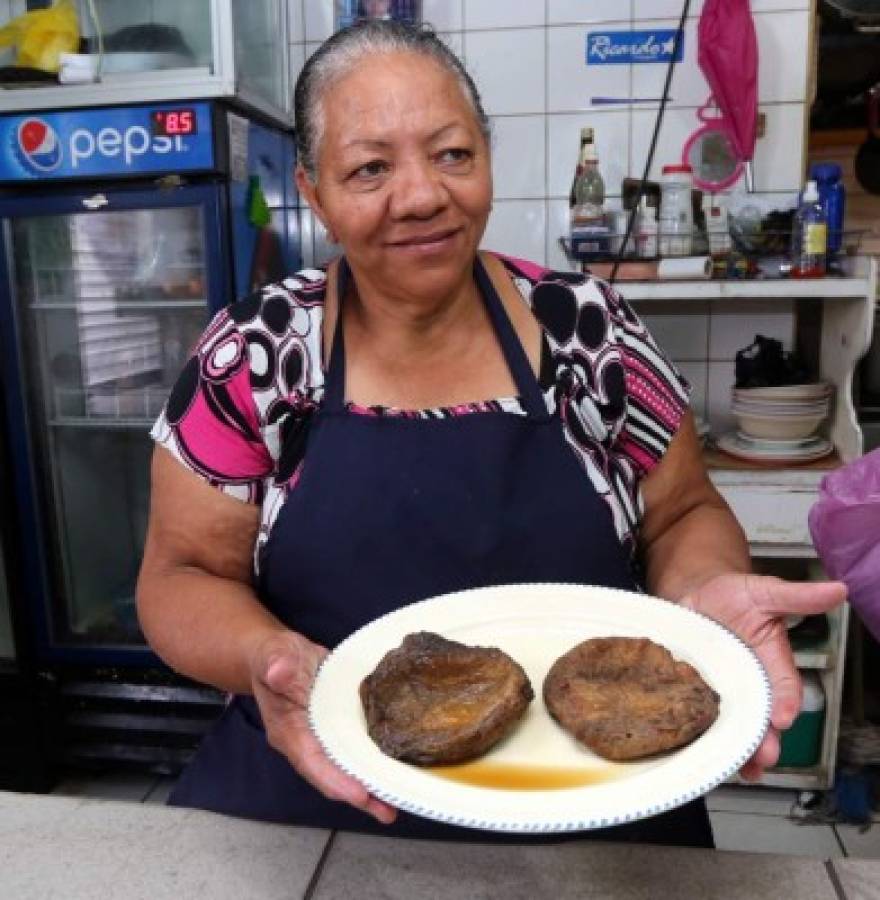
{"left": 544, "top": 638, "right": 720, "bottom": 760}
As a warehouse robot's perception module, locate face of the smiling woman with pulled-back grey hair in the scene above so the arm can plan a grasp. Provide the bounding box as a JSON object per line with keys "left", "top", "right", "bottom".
{"left": 298, "top": 53, "right": 492, "bottom": 304}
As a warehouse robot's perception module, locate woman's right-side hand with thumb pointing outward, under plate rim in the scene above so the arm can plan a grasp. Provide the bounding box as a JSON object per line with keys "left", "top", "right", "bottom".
{"left": 680, "top": 575, "right": 846, "bottom": 780}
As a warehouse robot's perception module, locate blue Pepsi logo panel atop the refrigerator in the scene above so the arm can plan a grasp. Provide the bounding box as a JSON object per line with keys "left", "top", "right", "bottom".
{"left": 0, "top": 103, "right": 214, "bottom": 182}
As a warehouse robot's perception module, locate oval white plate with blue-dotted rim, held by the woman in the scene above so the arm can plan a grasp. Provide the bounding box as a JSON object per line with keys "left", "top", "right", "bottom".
{"left": 309, "top": 584, "right": 770, "bottom": 833}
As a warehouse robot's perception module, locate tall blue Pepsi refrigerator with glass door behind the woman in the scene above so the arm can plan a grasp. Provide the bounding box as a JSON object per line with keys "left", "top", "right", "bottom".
{"left": 0, "top": 101, "right": 299, "bottom": 768}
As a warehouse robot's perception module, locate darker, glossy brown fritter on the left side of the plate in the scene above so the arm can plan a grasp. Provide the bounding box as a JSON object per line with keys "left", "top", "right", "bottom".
{"left": 360, "top": 631, "right": 535, "bottom": 766}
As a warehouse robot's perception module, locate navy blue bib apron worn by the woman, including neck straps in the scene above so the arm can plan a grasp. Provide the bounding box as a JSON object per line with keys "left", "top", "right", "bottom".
{"left": 169, "top": 260, "right": 712, "bottom": 847}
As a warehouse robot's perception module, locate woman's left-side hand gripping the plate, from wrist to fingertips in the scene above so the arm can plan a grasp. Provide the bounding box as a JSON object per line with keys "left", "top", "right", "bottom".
{"left": 251, "top": 632, "right": 397, "bottom": 825}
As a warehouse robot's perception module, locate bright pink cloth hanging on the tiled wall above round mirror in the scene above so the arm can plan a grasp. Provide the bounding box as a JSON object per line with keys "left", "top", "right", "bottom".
{"left": 697, "top": 0, "right": 758, "bottom": 168}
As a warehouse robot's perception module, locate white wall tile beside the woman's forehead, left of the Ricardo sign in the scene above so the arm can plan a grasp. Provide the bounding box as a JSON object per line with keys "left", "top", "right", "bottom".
{"left": 464, "top": 28, "right": 545, "bottom": 115}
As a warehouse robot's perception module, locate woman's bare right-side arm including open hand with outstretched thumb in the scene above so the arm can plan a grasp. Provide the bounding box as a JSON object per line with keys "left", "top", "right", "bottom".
{"left": 641, "top": 413, "right": 846, "bottom": 778}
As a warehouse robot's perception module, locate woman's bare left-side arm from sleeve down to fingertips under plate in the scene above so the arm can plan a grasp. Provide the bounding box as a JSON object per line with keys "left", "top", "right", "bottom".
{"left": 137, "top": 447, "right": 397, "bottom": 823}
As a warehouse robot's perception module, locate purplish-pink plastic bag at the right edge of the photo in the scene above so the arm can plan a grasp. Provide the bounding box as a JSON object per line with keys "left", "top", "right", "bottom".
{"left": 809, "top": 449, "right": 880, "bottom": 640}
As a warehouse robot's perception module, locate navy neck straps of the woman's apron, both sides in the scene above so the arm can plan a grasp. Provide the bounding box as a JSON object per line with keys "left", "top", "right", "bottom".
{"left": 324, "top": 256, "right": 549, "bottom": 419}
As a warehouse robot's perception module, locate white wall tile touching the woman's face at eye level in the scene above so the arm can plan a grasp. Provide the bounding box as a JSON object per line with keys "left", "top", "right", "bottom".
{"left": 492, "top": 116, "right": 547, "bottom": 200}
